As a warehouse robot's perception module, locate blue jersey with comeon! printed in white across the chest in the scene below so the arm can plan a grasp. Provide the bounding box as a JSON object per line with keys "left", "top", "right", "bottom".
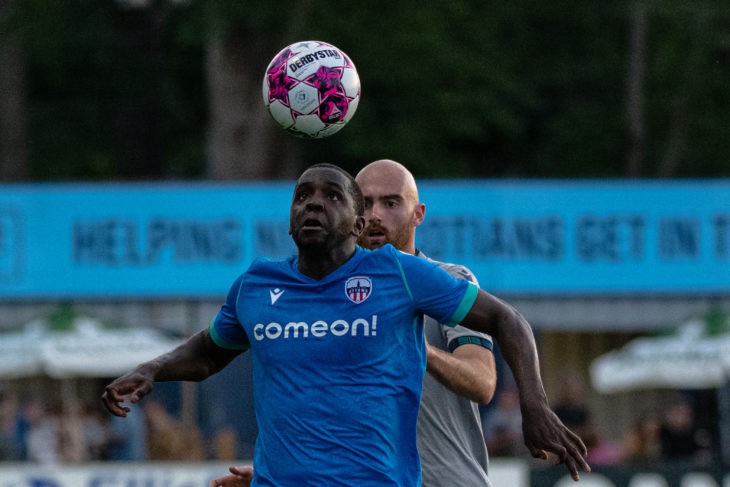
{"left": 210, "top": 245, "right": 477, "bottom": 487}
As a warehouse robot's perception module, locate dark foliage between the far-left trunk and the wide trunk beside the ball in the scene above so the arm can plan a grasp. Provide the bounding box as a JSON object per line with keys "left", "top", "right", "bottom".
{"left": 16, "top": 0, "right": 205, "bottom": 180}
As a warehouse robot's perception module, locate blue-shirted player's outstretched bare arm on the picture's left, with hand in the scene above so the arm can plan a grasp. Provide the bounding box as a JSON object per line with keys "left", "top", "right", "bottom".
{"left": 101, "top": 329, "right": 242, "bottom": 417}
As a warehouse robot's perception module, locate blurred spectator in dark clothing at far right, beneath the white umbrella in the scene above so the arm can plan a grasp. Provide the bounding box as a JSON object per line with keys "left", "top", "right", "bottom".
{"left": 659, "top": 398, "right": 710, "bottom": 465}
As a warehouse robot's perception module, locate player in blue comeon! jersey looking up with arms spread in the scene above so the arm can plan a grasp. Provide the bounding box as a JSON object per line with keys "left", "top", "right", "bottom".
{"left": 102, "top": 165, "right": 590, "bottom": 487}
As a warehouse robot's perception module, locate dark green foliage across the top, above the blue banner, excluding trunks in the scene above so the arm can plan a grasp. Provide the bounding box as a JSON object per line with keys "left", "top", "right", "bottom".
{"left": 6, "top": 0, "right": 730, "bottom": 180}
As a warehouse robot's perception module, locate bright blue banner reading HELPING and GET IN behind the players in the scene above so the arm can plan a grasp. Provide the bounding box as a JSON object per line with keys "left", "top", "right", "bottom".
{"left": 0, "top": 180, "right": 730, "bottom": 299}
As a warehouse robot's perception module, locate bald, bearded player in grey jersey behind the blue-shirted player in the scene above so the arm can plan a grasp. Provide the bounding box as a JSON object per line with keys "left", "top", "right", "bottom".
{"left": 355, "top": 159, "right": 497, "bottom": 487}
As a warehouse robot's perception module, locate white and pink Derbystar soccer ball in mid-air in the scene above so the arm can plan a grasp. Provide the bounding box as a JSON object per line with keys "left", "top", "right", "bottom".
{"left": 263, "top": 41, "right": 360, "bottom": 139}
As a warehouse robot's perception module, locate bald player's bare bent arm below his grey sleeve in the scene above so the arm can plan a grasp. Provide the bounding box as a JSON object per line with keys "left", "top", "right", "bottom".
{"left": 426, "top": 344, "right": 497, "bottom": 404}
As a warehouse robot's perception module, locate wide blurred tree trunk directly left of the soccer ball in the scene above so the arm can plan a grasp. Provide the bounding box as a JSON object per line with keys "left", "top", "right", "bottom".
{"left": 199, "top": 1, "right": 308, "bottom": 180}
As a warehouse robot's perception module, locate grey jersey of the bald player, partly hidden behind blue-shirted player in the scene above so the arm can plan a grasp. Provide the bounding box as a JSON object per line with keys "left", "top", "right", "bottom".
{"left": 416, "top": 251, "right": 492, "bottom": 487}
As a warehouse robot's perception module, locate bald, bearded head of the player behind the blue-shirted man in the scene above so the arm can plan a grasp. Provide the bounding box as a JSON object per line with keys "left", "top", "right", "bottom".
{"left": 355, "top": 159, "right": 425, "bottom": 254}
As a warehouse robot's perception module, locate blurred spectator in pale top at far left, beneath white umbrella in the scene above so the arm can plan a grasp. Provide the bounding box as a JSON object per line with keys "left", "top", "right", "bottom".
{"left": 24, "top": 400, "right": 60, "bottom": 464}
